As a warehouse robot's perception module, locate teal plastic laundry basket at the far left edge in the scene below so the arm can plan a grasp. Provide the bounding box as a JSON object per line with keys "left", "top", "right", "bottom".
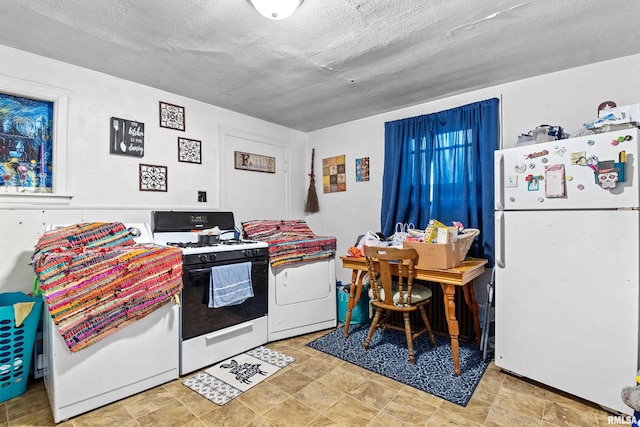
{"left": 0, "top": 292, "right": 42, "bottom": 402}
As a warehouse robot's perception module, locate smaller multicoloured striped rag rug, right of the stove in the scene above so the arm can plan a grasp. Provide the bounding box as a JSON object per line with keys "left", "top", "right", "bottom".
{"left": 242, "top": 220, "right": 336, "bottom": 267}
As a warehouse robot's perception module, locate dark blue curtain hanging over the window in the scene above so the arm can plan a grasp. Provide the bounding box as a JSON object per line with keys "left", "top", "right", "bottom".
{"left": 380, "top": 98, "right": 500, "bottom": 266}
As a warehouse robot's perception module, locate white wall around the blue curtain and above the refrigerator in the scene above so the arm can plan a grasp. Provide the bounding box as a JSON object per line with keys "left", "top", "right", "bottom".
{"left": 307, "top": 55, "right": 640, "bottom": 288}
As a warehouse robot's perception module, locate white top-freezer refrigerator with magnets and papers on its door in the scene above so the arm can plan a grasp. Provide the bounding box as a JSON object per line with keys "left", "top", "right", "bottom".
{"left": 495, "top": 129, "right": 640, "bottom": 414}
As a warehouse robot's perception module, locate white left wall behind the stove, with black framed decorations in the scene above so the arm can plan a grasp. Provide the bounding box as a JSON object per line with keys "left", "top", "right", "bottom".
{"left": 0, "top": 46, "right": 307, "bottom": 291}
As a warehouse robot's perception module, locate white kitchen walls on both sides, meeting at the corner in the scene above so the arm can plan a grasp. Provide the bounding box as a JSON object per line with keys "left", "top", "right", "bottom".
{"left": 5, "top": 46, "right": 640, "bottom": 298}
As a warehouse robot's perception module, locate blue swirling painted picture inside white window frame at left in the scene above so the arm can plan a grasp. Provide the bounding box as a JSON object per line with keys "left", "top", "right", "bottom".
{"left": 0, "top": 93, "right": 54, "bottom": 193}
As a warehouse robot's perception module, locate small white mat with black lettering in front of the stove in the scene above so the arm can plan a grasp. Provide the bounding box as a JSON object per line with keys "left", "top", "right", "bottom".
{"left": 182, "top": 346, "right": 295, "bottom": 405}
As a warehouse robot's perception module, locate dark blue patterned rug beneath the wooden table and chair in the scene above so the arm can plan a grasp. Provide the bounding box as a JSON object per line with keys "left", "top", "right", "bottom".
{"left": 307, "top": 323, "right": 490, "bottom": 406}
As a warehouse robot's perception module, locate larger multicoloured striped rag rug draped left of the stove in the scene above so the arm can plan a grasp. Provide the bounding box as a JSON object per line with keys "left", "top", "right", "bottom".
{"left": 32, "top": 223, "right": 182, "bottom": 352}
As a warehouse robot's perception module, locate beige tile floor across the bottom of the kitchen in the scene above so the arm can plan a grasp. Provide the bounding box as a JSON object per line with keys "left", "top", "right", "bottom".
{"left": 0, "top": 331, "right": 612, "bottom": 427}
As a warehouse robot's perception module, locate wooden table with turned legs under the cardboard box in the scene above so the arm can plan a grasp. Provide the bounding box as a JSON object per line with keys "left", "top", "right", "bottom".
{"left": 340, "top": 256, "right": 487, "bottom": 375}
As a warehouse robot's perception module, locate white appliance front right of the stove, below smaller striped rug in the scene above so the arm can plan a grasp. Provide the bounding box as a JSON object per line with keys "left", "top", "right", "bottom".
{"left": 268, "top": 258, "right": 337, "bottom": 342}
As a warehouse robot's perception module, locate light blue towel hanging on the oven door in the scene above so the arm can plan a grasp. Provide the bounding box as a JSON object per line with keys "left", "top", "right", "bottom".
{"left": 208, "top": 262, "right": 253, "bottom": 308}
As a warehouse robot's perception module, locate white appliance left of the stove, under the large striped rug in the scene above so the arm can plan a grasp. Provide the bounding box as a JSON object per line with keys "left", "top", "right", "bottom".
{"left": 42, "top": 224, "right": 180, "bottom": 423}
